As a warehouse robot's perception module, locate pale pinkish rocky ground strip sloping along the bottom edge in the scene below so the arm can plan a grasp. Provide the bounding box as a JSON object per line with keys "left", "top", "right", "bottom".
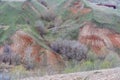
{"left": 21, "top": 68, "right": 120, "bottom": 80}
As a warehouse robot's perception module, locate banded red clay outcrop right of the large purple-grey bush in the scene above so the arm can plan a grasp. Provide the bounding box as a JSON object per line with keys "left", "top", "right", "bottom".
{"left": 79, "top": 22, "right": 120, "bottom": 55}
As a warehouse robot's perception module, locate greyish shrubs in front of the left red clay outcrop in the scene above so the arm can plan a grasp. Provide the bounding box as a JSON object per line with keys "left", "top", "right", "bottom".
{"left": 0, "top": 44, "right": 35, "bottom": 69}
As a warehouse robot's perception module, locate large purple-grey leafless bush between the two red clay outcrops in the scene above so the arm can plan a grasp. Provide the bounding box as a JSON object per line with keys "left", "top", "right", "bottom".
{"left": 51, "top": 40, "right": 88, "bottom": 61}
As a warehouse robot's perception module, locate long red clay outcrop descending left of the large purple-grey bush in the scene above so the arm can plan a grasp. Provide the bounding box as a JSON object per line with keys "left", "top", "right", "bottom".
{"left": 0, "top": 30, "right": 64, "bottom": 72}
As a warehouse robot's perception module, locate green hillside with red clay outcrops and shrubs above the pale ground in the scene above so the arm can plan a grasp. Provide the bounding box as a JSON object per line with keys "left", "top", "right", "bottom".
{"left": 0, "top": 0, "right": 120, "bottom": 80}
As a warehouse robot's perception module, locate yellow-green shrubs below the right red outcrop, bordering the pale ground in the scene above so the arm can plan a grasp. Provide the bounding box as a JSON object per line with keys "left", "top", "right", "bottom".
{"left": 64, "top": 51, "right": 120, "bottom": 73}
